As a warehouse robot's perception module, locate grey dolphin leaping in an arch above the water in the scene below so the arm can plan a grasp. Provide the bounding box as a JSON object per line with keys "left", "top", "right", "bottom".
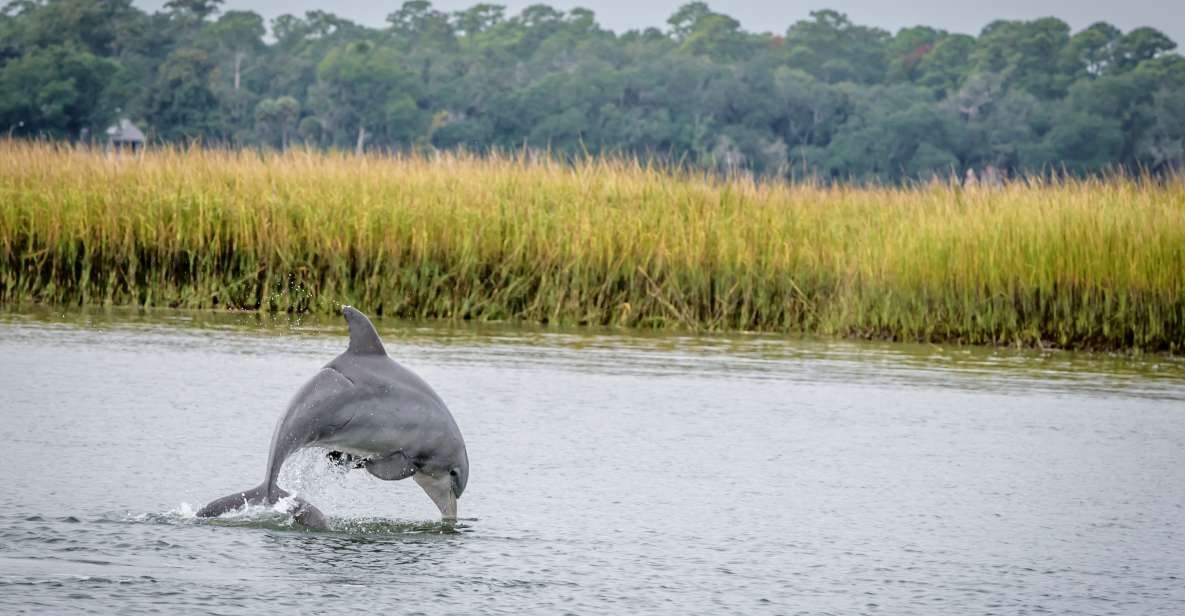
{"left": 198, "top": 306, "right": 469, "bottom": 528}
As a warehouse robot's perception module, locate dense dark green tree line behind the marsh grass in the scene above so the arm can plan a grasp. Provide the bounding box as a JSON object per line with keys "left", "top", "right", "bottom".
{"left": 0, "top": 0, "right": 1185, "bottom": 181}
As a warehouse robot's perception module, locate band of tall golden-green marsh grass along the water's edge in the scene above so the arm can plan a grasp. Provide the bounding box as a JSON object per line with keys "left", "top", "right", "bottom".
{"left": 0, "top": 141, "right": 1185, "bottom": 352}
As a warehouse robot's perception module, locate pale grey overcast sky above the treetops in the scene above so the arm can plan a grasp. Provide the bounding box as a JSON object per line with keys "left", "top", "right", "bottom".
{"left": 136, "top": 0, "right": 1185, "bottom": 45}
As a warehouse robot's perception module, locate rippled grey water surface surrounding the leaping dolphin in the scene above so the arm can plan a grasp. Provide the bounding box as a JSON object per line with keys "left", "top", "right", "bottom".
{"left": 0, "top": 312, "right": 1185, "bottom": 615}
